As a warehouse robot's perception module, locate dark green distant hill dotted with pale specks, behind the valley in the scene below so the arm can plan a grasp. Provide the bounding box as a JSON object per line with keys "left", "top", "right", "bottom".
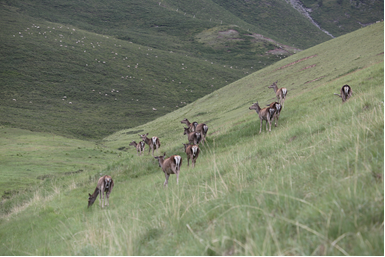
{"left": 0, "top": 0, "right": 383, "bottom": 139}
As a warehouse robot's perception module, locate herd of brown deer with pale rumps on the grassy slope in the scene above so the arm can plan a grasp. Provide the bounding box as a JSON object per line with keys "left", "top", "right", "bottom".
{"left": 88, "top": 81, "right": 353, "bottom": 208}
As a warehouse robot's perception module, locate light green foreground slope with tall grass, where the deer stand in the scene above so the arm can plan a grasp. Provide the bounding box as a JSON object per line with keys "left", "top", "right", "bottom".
{"left": 0, "top": 23, "right": 384, "bottom": 255}
